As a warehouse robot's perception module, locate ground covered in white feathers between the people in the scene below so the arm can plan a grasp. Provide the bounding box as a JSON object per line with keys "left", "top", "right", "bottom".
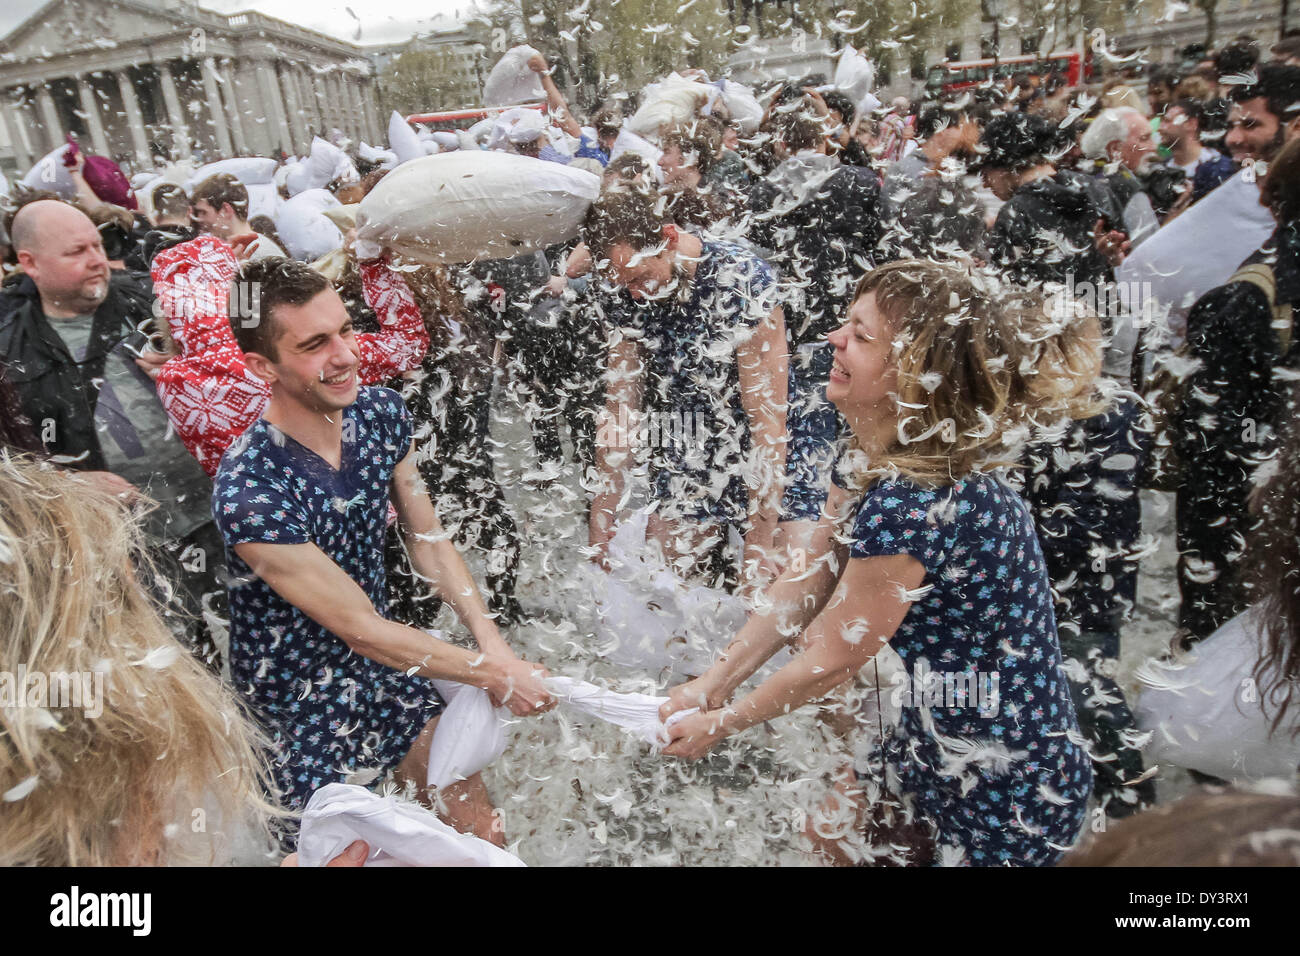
{"left": 423, "top": 385, "right": 1190, "bottom": 865}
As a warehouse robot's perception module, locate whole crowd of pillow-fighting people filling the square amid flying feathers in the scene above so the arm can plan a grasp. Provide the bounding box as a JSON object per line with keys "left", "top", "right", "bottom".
{"left": 0, "top": 31, "right": 1300, "bottom": 865}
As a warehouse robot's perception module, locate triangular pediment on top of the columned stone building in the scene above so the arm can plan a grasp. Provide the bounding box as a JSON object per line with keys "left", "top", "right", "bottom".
{"left": 0, "top": 0, "right": 194, "bottom": 62}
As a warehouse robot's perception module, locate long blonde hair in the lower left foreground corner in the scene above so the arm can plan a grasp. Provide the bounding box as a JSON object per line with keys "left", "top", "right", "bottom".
{"left": 0, "top": 454, "right": 283, "bottom": 866}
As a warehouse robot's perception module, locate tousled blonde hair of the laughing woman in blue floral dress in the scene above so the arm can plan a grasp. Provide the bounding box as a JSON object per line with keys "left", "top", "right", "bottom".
{"left": 853, "top": 259, "right": 1104, "bottom": 486}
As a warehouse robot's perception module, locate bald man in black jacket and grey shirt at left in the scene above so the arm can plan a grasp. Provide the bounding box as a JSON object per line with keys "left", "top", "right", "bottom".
{"left": 0, "top": 199, "right": 222, "bottom": 665}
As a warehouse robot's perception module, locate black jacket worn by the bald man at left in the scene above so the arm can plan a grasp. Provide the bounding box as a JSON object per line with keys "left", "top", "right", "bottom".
{"left": 0, "top": 273, "right": 153, "bottom": 471}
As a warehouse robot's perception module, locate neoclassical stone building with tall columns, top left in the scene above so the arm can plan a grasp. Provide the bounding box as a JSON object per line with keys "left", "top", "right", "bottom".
{"left": 0, "top": 0, "right": 384, "bottom": 170}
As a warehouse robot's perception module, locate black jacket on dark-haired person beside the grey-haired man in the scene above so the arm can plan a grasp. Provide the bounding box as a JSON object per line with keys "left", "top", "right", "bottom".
{"left": 988, "top": 169, "right": 1123, "bottom": 285}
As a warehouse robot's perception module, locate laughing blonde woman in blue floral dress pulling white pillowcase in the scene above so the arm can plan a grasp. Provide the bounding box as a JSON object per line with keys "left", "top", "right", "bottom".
{"left": 662, "top": 260, "right": 1100, "bottom": 866}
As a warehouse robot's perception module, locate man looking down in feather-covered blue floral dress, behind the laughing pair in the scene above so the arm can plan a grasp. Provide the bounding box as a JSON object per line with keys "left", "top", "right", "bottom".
{"left": 584, "top": 190, "right": 789, "bottom": 587}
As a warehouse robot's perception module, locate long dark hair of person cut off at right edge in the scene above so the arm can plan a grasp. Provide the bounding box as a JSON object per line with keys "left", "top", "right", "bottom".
{"left": 1247, "top": 382, "right": 1300, "bottom": 735}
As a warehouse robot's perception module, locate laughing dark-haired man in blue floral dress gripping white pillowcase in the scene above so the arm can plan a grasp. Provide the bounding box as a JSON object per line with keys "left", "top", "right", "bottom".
{"left": 212, "top": 259, "right": 554, "bottom": 843}
